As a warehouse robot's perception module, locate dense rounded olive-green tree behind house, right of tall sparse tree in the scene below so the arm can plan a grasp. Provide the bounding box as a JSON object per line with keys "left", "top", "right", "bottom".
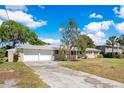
{"left": 79, "top": 35, "right": 95, "bottom": 53}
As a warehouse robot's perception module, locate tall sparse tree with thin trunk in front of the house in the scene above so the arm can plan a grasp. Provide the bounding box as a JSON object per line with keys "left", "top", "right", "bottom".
{"left": 61, "top": 19, "right": 80, "bottom": 59}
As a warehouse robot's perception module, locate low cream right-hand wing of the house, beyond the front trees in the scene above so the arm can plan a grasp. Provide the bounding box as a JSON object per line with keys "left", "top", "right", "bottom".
{"left": 86, "top": 48, "right": 101, "bottom": 58}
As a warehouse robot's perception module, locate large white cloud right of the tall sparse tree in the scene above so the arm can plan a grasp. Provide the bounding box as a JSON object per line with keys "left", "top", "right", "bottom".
{"left": 81, "top": 20, "right": 114, "bottom": 45}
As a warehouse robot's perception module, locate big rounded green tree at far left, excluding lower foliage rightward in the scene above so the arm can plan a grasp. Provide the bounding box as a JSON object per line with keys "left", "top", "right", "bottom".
{"left": 0, "top": 20, "right": 29, "bottom": 47}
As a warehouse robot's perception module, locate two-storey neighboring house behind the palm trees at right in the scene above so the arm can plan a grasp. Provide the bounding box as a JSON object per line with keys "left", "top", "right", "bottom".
{"left": 96, "top": 45, "right": 123, "bottom": 54}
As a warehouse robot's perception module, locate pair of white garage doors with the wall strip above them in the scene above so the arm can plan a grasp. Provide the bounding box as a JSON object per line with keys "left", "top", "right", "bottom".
{"left": 24, "top": 49, "right": 54, "bottom": 62}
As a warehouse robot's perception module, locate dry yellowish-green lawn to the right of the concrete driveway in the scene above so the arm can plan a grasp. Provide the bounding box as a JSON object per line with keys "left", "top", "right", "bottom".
{"left": 61, "top": 58, "right": 124, "bottom": 83}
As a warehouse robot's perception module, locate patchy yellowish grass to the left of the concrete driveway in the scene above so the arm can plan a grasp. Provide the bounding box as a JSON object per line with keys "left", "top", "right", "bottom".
{"left": 0, "top": 62, "right": 48, "bottom": 88}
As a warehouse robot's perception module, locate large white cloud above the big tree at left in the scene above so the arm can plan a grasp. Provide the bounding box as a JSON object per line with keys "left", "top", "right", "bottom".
{"left": 0, "top": 9, "right": 47, "bottom": 28}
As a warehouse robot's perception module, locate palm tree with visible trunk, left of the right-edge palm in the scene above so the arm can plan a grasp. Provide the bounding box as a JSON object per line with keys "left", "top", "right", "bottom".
{"left": 106, "top": 36, "right": 118, "bottom": 55}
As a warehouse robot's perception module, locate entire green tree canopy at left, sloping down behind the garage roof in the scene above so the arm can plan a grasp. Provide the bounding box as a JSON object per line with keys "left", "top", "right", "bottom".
{"left": 0, "top": 20, "right": 45, "bottom": 47}
